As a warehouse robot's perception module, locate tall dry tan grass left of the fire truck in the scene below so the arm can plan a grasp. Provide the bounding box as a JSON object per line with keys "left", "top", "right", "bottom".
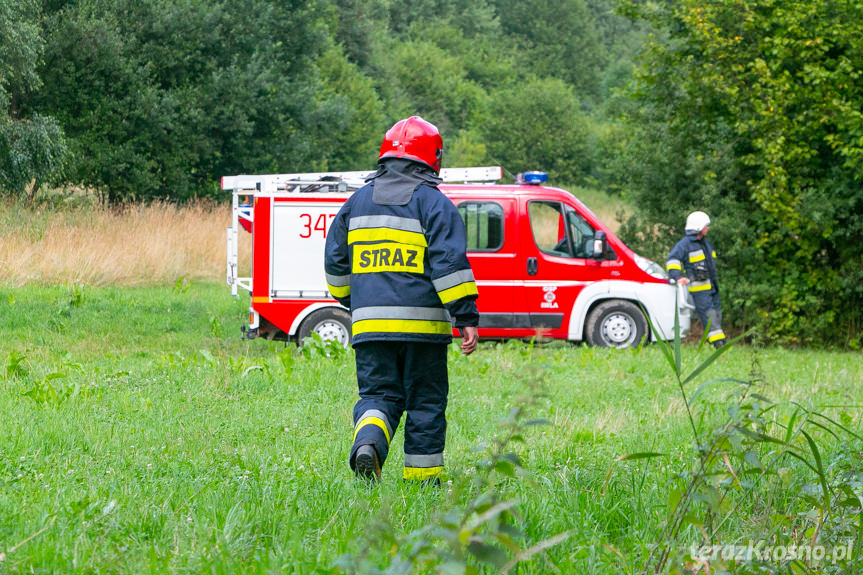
{"left": 0, "top": 202, "right": 243, "bottom": 286}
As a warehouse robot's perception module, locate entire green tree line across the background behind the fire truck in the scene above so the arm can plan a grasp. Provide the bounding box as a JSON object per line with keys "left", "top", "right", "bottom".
{"left": 0, "top": 0, "right": 863, "bottom": 346}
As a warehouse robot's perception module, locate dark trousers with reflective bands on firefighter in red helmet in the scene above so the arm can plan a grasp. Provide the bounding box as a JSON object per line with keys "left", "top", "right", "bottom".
{"left": 350, "top": 341, "right": 449, "bottom": 480}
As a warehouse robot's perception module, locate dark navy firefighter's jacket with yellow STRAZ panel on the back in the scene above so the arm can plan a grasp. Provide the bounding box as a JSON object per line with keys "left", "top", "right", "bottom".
{"left": 325, "top": 162, "right": 479, "bottom": 344}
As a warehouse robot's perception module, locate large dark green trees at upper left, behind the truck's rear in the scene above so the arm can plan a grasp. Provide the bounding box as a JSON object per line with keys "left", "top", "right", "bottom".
{"left": 34, "top": 0, "right": 364, "bottom": 199}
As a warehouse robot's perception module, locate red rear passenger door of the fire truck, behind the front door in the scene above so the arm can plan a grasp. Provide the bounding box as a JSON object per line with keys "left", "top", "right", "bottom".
{"left": 456, "top": 199, "right": 531, "bottom": 337}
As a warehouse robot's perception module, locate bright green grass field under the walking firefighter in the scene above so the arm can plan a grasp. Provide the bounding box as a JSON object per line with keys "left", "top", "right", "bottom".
{"left": 0, "top": 283, "right": 863, "bottom": 574}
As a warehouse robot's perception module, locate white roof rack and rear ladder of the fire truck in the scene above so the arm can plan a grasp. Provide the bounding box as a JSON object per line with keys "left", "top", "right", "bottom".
{"left": 221, "top": 166, "right": 503, "bottom": 296}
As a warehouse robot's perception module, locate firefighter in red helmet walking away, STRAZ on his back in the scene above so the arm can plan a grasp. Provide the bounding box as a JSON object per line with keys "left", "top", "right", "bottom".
{"left": 325, "top": 116, "right": 479, "bottom": 483}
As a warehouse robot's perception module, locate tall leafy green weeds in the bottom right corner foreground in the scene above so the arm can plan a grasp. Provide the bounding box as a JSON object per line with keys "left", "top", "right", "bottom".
{"left": 640, "top": 308, "right": 863, "bottom": 575}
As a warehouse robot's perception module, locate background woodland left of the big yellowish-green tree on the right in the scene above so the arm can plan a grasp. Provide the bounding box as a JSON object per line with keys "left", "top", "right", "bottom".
{"left": 0, "top": 0, "right": 648, "bottom": 201}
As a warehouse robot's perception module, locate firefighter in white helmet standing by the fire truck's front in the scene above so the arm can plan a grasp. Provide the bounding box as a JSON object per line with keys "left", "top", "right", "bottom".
{"left": 665, "top": 212, "right": 726, "bottom": 348}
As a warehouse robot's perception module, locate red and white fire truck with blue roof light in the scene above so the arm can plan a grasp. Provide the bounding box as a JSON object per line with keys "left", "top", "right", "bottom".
{"left": 222, "top": 167, "right": 690, "bottom": 347}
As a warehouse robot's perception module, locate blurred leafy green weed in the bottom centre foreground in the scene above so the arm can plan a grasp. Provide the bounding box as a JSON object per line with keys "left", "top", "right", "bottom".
{"left": 336, "top": 372, "right": 569, "bottom": 575}
